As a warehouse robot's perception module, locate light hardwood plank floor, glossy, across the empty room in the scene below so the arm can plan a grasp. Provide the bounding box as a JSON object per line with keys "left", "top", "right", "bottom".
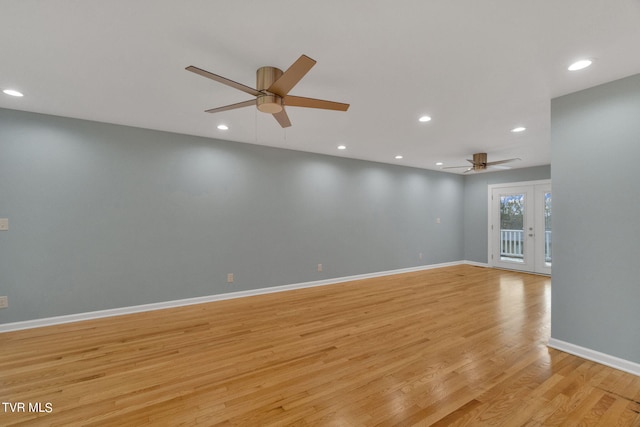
{"left": 0, "top": 265, "right": 640, "bottom": 426}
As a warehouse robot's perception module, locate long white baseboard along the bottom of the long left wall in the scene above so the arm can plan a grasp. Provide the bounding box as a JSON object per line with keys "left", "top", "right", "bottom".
{"left": 0, "top": 261, "right": 476, "bottom": 333}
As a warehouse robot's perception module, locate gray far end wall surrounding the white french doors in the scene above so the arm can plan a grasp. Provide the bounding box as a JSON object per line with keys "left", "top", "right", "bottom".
{"left": 464, "top": 166, "right": 551, "bottom": 263}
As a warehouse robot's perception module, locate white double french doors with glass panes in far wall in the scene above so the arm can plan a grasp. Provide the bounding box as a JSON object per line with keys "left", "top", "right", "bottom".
{"left": 488, "top": 180, "right": 552, "bottom": 274}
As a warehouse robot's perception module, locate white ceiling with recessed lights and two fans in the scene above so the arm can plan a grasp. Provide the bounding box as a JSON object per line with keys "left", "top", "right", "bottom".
{"left": 0, "top": 0, "right": 640, "bottom": 173}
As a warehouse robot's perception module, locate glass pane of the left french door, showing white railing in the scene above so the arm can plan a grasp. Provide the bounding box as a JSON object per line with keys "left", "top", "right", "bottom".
{"left": 500, "top": 194, "right": 525, "bottom": 263}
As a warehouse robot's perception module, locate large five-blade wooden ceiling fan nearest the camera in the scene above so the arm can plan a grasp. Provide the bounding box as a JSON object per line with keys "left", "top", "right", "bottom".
{"left": 186, "top": 55, "right": 349, "bottom": 128}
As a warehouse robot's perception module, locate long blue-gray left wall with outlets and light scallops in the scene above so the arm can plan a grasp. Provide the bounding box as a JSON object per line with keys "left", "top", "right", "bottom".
{"left": 0, "top": 109, "right": 464, "bottom": 323}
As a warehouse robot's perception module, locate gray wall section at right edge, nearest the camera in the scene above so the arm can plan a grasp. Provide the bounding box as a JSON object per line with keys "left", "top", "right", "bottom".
{"left": 551, "top": 75, "right": 640, "bottom": 363}
